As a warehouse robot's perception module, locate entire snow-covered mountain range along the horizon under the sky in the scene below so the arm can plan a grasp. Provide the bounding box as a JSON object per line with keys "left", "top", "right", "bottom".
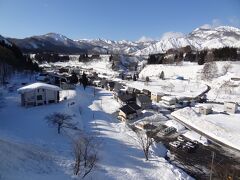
{"left": 5, "top": 26, "right": 240, "bottom": 55}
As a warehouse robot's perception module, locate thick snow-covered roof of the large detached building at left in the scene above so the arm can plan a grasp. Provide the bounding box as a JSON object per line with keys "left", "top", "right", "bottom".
{"left": 17, "top": 82, "right": 62, "bottom": 93}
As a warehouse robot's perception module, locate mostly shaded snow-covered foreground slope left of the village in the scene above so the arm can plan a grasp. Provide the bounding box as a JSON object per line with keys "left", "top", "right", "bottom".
{"left": 0, "top": 75, "right": 191, "bottom": 180}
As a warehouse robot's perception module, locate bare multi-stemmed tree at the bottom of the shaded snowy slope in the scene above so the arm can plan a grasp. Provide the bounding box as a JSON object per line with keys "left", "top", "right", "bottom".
{"left": 73, "top": 135, "right": 98, "bottom": 178}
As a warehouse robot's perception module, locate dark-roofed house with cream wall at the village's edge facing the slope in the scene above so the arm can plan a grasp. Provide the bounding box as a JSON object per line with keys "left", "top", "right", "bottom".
{"left": 118, "top": 103, "right": 141, "bottom": 121}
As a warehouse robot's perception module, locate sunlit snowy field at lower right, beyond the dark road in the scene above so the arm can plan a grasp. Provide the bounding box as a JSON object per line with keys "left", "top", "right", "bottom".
{"left": 172, "top": 104, "right": 240, "bottom": 150}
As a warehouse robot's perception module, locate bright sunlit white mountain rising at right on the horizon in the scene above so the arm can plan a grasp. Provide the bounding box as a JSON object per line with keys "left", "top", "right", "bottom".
{"left": 134, "top": 26, "right": 240, "bottom": 55}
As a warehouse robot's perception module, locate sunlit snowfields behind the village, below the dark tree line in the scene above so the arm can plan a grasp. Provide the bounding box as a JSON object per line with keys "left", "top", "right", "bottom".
{"left": 42, "top": 55, "right": 240, "bottom": 103}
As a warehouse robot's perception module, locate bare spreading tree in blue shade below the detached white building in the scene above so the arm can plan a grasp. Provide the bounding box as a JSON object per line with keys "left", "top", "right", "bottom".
{"left": 45, "top": 112, "right": 76, "bottom": 134}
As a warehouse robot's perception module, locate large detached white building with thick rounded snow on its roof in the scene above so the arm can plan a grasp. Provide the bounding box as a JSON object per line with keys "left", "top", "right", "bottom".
{"left": 18, "top": 83, "right": 62, "bottom": 106}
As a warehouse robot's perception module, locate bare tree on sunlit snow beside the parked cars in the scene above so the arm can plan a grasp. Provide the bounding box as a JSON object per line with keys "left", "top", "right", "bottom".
{"left": 136, "top": 130, "right": 154, "bottom": 161}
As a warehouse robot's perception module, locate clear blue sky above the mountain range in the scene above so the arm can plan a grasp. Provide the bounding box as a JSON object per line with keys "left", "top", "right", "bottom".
{"left": 0, "top": 0, "right": 240, "bottom": 40}
